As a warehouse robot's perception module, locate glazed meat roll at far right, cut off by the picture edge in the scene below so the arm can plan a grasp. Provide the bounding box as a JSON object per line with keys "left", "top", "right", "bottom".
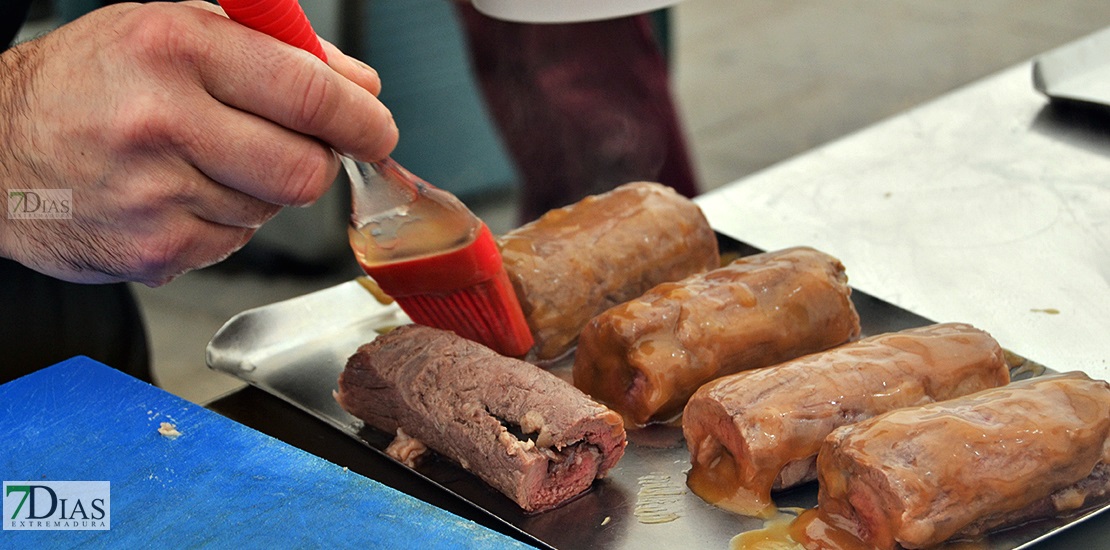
{"left": 817, "top": 372, "right": 1110, "bottom": 549}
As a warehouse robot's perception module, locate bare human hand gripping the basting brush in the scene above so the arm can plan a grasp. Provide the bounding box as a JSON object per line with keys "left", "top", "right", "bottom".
{"left": 0, "top": 1, "right": 397, "bottom": 286}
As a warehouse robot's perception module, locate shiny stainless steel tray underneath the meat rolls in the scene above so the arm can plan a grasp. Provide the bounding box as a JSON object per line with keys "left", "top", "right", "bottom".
{"left": 206, "top": 237, "right": 1110, "bottom": 549}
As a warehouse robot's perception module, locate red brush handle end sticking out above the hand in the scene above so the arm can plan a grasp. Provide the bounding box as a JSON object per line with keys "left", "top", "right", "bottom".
{"left": 220, "top": 0, "right": 327, "bottom": 63}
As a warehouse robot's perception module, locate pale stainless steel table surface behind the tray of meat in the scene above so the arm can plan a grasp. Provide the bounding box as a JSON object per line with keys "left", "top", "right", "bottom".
{"left": 697, "top": 33, "right": 1110, "bottom": 549}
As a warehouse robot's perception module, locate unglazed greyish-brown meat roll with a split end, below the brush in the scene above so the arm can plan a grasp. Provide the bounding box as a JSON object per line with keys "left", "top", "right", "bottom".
{"left": 335, "top": 324, "right": 625, "bottom": 512}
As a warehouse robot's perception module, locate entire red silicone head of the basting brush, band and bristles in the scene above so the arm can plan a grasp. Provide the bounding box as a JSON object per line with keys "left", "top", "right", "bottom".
{"left": 365, "top": 223, "right": 534, "bottom": 357}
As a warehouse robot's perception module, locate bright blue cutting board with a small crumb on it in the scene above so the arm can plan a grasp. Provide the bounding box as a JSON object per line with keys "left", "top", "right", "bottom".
{"left": 0, "top": 357, "right": 528, "bottom": 550}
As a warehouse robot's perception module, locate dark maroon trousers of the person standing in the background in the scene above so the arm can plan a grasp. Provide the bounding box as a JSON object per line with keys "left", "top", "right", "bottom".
{"left": 456, "top": 3, "right": 698, "bottom": 222}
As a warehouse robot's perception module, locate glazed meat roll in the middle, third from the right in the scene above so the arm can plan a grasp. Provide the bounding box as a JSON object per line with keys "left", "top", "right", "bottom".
{"left": 574, "top": 248, "right": 859, "bottom": 426}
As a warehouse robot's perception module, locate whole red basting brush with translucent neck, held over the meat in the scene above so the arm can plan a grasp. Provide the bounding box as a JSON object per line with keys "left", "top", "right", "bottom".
{"left": 220, "top": 0, "right": 533, "bottom": 357}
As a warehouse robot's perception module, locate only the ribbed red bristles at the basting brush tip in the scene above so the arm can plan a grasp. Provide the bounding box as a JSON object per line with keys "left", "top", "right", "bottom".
{"left": 396, "top": 279, "right": 533, "bottom": 357}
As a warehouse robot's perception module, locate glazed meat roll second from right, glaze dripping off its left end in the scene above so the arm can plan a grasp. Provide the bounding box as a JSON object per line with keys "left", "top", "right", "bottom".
{"left": 683, "top": 323, "right": 1010, "bottom": 516}
